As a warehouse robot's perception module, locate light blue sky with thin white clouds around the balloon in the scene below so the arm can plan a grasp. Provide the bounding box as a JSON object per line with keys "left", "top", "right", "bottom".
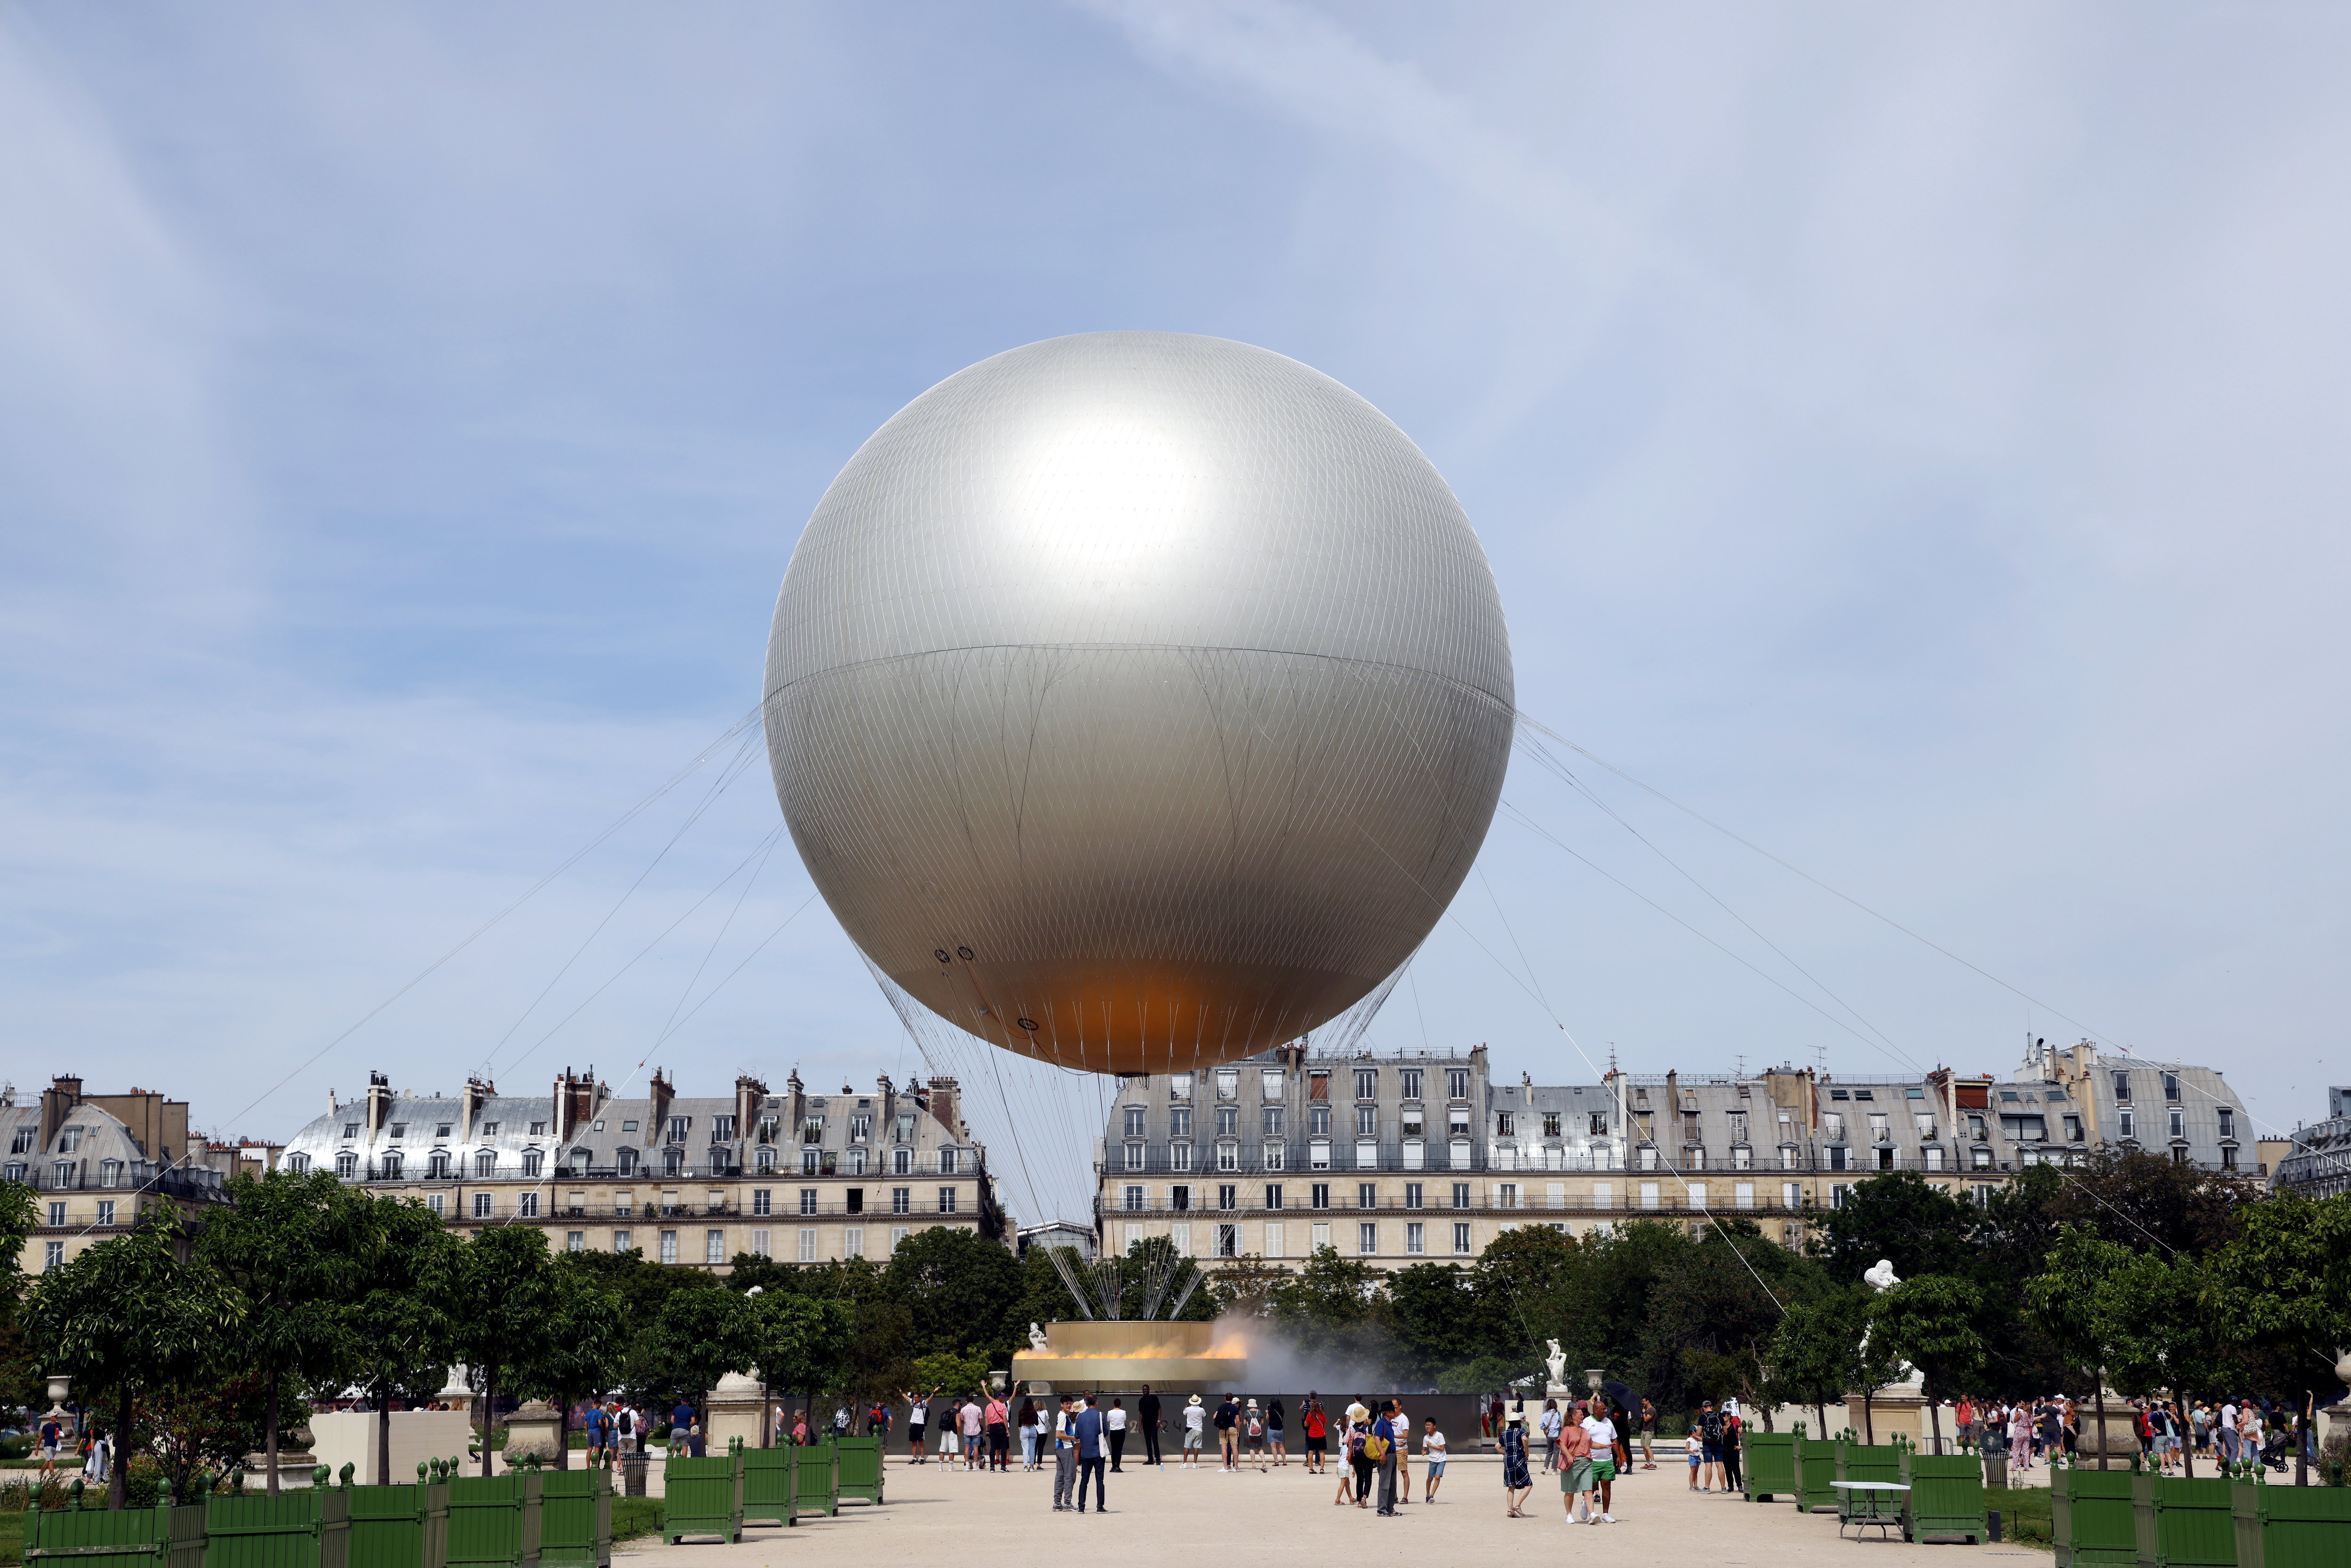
{"left": 0, "top": 0, "right": 2351, "bottom": 1220}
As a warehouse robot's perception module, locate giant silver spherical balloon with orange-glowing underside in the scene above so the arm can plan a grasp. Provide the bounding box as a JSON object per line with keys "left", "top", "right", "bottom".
{"left": 766, "top": 331, "right": 1514, "bottom": 1072}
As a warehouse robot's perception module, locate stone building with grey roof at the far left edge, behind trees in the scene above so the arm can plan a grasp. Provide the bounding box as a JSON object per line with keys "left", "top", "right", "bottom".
{"left": 0, "top": 1077, "right": 223, "bottom": 1274}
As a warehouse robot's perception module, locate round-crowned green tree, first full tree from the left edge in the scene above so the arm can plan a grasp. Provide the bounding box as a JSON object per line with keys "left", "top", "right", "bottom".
{"left": 26, "top": 1204, "right": 245, "bottom": 1507}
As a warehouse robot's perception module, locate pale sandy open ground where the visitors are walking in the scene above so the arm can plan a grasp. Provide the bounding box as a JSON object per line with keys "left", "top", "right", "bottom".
{"left": 614, "top": 1453, "right": 2048, "bottom": 1568}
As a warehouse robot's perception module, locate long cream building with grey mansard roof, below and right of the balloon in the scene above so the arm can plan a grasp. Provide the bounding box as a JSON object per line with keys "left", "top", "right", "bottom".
{"left": 1096, "top": 1046, "right": 2245, "bottom": 1269}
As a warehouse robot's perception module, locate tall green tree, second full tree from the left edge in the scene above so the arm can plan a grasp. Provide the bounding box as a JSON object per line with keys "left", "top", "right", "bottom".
{"left": 195, "top": 1171, "right": 371, "bottom": 1497}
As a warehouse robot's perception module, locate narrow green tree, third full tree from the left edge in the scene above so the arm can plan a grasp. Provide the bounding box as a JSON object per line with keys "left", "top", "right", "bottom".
{"left": 343, "top": 1197, "right": 458, "bottom": 1486}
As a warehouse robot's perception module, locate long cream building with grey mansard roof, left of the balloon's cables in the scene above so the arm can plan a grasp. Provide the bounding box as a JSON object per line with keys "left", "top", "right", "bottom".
{"left": 282, "top": 1067, "right": 1006, "bottom": 1272}
